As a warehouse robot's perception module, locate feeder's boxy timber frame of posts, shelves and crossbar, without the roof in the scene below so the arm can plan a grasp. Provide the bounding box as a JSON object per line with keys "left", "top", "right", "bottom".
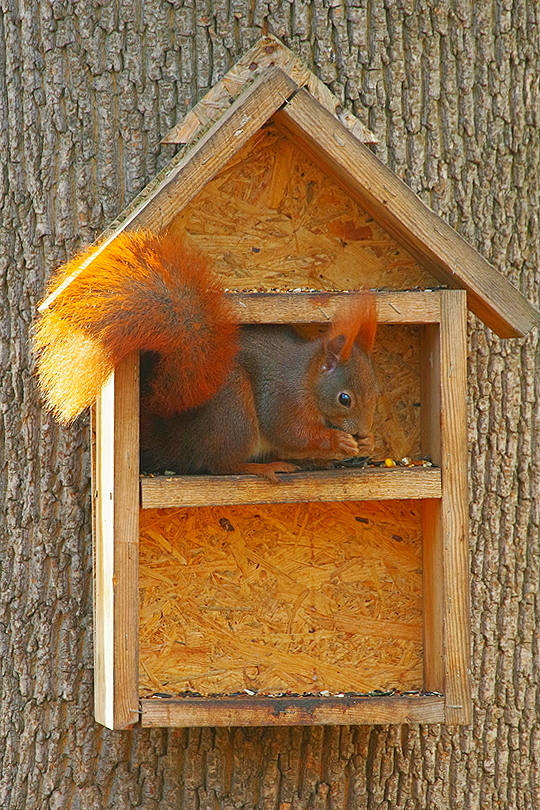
{"left": 95, "top": 290, "right": 471, "bottom": 728}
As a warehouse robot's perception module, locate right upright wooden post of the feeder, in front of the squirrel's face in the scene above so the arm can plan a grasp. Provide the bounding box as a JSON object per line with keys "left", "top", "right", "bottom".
{"left": 422, "top": 290, "right": 472, "bottom": 724}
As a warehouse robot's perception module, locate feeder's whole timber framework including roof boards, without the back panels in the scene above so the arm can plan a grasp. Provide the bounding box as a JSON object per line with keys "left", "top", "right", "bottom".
{"left": 33, "top": 38, "right": 540, "bottom": 728}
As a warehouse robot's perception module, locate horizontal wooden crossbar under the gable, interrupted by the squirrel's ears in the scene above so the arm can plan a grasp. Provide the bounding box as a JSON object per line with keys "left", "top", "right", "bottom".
{"left": 227, "top": 290, "right": 441, "bottom": 323}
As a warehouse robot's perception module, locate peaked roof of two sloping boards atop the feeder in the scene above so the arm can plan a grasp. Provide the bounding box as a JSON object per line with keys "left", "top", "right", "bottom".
{"left": 40, "top": 54, "right": 540, "bottom": 337}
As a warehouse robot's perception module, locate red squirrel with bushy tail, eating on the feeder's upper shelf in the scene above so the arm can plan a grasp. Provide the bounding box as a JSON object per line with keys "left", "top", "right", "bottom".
{"left": 35, "top": 231, "right": 376, "bottom": 481}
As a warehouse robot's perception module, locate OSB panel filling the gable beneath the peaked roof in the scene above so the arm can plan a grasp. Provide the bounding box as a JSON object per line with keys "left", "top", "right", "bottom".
{"left": 170, "top": 123, "right": 440, "bottom": 290}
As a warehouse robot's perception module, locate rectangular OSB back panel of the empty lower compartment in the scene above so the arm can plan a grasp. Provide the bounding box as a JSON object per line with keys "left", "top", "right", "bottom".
{"left": 140, "top": 501, "right": 422, "bottom": 695}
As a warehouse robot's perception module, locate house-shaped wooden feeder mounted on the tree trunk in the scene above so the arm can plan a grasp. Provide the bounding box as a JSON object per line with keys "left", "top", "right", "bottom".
{"left": 44, "top": 37, "right": 540, "bottom": 729}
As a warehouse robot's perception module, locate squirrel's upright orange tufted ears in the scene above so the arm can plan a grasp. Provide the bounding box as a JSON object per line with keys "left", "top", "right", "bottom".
{"left": 325, "top": 290, "right": 377, "bottom": 361}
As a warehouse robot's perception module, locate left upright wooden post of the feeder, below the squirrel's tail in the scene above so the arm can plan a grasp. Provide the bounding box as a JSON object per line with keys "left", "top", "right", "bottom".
{"left": 94, "top": 354, "right": 139, "bottom": 729}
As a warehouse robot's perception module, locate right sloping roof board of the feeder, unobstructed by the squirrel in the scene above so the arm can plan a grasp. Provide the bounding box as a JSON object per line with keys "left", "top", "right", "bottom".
{"left": 274, "top": 89, "right": 540, "bottom": 337}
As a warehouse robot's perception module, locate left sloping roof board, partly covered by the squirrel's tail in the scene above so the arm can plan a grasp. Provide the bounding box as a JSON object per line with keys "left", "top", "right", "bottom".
{"left": 39, "top": 67, "right": 300, "bottom": 312}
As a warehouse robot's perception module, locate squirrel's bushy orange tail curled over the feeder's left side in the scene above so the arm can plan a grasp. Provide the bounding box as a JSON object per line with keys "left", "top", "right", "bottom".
{"left": 35, "top": 231, "right": 237, "bottom": 423}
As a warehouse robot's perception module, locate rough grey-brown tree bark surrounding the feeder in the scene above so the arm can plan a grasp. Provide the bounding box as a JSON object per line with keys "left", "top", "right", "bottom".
{"left": 0, "top": 0, "right": 540, "bottom": 810}
